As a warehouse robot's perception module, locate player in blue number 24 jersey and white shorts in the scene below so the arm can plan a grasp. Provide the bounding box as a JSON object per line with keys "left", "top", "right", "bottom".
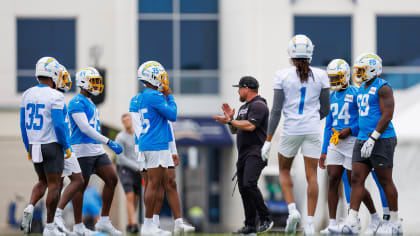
{"left": 319, "top": 59, "right": 381, "bottom": 234}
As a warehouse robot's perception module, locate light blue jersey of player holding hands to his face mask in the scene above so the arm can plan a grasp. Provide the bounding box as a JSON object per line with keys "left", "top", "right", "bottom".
{"left": 136, "top": 88, "right": 177, "bottom": 151}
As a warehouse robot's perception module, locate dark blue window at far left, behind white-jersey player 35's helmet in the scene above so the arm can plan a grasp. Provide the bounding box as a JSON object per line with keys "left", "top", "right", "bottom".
{"left": 17, "top": 18, "right": 76, "bottom": 92}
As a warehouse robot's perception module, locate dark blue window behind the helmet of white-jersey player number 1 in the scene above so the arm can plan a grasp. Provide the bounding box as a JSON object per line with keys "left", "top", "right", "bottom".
{"left": 294, "top": 16, "right": 352, "bottom": 66}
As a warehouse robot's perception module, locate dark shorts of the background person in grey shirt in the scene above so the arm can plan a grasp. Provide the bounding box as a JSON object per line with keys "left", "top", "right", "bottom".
{"left": 118, "top": 166, "right": 141, "bottom": 195}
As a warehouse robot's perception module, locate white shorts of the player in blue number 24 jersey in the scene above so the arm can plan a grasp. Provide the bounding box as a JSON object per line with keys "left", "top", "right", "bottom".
{"left": 326, "top": 136, "right": 356, "bottom": 170}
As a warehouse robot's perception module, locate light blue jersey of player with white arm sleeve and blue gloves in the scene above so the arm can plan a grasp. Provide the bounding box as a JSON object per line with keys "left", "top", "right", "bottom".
{"left": 69, "top": 94, "right": 101, "bottom": 145}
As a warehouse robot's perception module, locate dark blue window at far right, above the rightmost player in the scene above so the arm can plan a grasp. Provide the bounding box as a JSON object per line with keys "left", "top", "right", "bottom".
{"left": 377, "top": 16, "right": 420, "bottom": 66}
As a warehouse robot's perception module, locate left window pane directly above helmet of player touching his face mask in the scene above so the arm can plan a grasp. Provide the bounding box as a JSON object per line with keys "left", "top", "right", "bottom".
{"left": 139, "top": 20, "right": 173, "bottom": 69}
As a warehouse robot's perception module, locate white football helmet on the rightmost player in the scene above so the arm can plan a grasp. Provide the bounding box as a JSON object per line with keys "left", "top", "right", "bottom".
{"left": 353, "top": 53, "right": 382, "bottom": 85}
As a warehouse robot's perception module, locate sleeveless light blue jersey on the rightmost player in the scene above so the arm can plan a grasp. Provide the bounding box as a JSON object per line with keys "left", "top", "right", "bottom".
{"left": 357, "top": 78, "right": 396, "bottom": 140}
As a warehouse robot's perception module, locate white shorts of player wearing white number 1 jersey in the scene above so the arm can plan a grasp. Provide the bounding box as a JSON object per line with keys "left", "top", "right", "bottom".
{"left": 279, "top": 134, "right": 321, "bottom": 159}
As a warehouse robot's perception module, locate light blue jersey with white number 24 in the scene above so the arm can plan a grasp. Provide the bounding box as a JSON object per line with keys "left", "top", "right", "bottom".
{"left": 322, "top": 86, "right": 359, "bottom": 153}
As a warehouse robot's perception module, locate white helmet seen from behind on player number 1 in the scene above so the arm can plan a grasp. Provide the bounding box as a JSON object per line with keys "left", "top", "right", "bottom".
{"left": 287, "top": 34, "right": 315, "bottom": 60}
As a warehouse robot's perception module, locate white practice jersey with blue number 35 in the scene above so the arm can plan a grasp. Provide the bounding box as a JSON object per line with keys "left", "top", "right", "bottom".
{"left": 21, "top": 85, "right": 64, "bottom": 144}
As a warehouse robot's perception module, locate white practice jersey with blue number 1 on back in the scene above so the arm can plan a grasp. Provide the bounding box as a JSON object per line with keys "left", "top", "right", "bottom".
{"left": 274, "top": 66, "right": 330, "bottom": 135}
